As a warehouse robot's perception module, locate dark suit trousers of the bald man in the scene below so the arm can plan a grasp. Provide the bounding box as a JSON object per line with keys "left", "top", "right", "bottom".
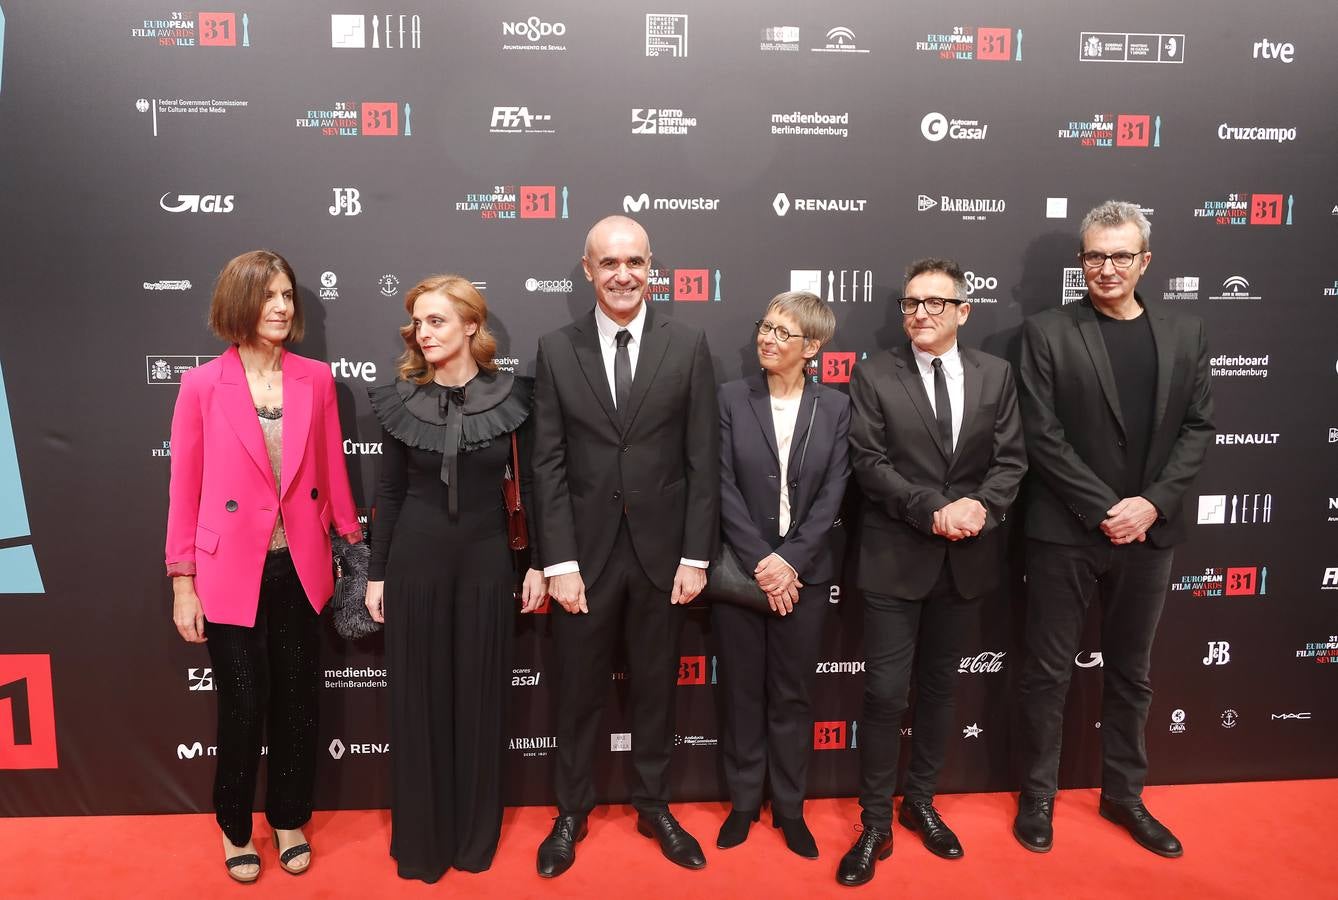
{"left": 553, "top": 520, "right": 686, "bottom": 816}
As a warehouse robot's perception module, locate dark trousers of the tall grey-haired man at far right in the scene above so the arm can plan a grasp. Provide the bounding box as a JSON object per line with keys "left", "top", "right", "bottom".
{"left": 1020, "top": 540, "right": 1172, "bottom": 804}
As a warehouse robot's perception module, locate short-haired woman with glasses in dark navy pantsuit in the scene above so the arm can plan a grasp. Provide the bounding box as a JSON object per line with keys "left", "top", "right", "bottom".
{"left": 710, "top": 292, "right": 850, "bottom": 859}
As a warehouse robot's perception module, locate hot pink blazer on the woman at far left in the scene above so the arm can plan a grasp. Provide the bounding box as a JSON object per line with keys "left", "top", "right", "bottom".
{"left": 167, "top": 346, "right": 361, "bottom": 627}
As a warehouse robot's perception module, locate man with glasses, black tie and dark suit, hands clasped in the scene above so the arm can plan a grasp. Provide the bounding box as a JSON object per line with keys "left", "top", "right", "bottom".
{"left": 836, "top": 259, "right": 1026, "bottom": 885}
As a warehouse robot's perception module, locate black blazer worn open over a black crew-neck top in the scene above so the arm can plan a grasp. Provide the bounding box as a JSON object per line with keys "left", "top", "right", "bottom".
{"left": 1020, "top": 297, "right": 1214, "bottom": 547}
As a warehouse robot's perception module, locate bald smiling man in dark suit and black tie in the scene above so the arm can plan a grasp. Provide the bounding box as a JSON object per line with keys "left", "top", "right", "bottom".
{"left": 534, "top": 215, "right": 720, "bottom": 877}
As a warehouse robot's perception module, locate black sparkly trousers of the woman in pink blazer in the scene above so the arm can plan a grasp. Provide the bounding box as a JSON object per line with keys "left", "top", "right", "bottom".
{"left": 205, "top": 550, "right": 320, "bottom": 847}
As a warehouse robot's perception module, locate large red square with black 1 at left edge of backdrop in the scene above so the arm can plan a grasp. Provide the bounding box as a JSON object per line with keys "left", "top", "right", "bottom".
{"left": 0, "top": 654, "right": 59, "bottom": 770}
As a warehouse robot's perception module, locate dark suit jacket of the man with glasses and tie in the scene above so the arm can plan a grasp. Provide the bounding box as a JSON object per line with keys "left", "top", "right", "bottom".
{"left": 850, "top": 342, "right": 1026, "bottom": 599}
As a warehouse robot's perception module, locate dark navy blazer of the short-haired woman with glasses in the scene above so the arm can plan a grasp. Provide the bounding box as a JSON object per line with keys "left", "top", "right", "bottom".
{"left": 720, "top": 373, "right": 850, "bottom": 584}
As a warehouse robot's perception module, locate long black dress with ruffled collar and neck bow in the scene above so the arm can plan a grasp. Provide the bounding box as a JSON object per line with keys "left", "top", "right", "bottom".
{"left": 368, "top": 372, "right": 534, "bottom": 883}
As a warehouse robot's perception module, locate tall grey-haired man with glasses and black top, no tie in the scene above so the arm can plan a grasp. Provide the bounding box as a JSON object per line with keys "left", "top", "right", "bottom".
{"left": 1013, "top": 201, "right": 1214, "bottom": 856}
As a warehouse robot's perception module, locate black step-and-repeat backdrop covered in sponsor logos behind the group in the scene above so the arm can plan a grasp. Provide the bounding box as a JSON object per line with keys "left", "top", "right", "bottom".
{"left": 0, "top": 0, "right": 1338, "bottom": 814}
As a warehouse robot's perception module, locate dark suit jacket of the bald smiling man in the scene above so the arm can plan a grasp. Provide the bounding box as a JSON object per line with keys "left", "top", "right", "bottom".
{"left": 533, "top": 306, "right": 720, "bottom": 591}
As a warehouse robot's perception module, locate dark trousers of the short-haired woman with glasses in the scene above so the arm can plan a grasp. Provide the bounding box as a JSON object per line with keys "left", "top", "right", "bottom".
{"left": 710, "top": 583, "right": 831, "bottom": 818}
